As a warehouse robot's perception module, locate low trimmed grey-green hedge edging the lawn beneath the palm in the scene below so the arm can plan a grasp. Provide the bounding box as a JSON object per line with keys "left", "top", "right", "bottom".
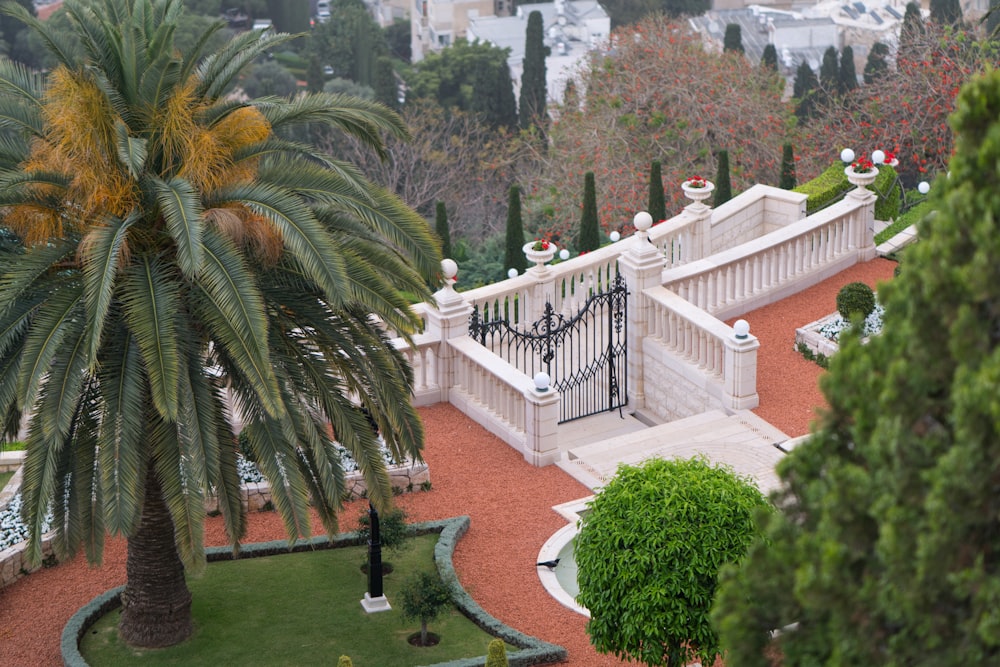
{"left": 61, "top": 516, "right": 567, "bottom": 667}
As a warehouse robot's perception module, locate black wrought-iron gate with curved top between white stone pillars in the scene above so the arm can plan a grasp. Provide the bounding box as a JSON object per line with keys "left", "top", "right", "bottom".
{"left": 469, "top": 274, "right": 628, "bottom": 424}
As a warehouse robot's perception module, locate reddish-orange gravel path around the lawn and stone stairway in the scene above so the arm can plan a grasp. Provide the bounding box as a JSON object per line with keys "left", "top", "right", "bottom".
{"left": 0, "top": 259, "right": 895, "bottom": 667}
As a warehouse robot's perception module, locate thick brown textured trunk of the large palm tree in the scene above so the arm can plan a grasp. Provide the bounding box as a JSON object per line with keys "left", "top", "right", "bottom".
{"left": 118, "top": 468, "right": 192, "bottom": 648}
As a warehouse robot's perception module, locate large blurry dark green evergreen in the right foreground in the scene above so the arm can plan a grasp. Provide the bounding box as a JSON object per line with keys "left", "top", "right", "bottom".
{"left": 715, "top": 70, "right": 1000, "bottom": 667}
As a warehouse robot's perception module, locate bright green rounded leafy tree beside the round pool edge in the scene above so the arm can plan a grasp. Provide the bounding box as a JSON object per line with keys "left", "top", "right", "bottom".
{"left": 576, "top": 458, "right": 768, "bottom": 667}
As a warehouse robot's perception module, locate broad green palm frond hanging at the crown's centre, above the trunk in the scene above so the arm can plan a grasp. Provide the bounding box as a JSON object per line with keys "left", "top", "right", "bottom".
{"left": 121, "top": 255, "right": 181, "bottom": 421}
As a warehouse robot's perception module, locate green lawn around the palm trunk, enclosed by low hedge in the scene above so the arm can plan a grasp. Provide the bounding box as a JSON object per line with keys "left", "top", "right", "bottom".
{"left": 80, "top": 534, "right": 513, "bottom": 667}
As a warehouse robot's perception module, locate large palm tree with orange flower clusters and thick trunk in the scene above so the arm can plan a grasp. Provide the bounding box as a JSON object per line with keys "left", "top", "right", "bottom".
{"left": 0, "top": 0, "right": 440, "bottom": 646}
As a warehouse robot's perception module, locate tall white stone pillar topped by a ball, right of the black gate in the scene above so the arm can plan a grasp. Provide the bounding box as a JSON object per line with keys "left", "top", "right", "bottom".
{"left": 618, "top": 211, "right": 663, "bottom": 410}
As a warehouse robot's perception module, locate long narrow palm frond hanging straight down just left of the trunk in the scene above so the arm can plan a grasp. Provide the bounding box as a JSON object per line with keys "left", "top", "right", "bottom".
{"left": 98, "top": 327, "right": 149, "bottom": 535}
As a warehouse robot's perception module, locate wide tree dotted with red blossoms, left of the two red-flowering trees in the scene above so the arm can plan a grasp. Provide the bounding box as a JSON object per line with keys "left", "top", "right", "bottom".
{"left": 518, "top": 16, "right": 787, "bottom": 243}
